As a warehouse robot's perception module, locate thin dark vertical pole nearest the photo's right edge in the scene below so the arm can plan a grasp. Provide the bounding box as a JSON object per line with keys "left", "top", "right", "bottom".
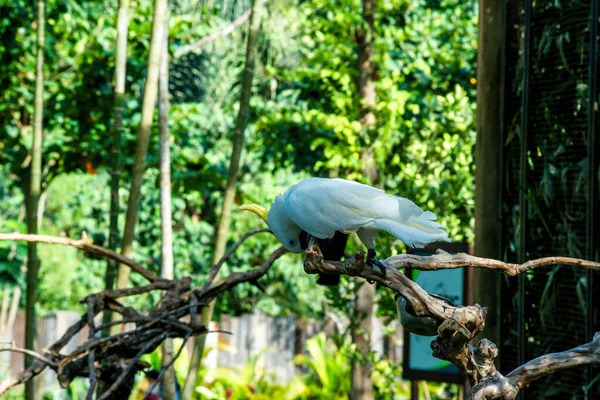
{"left": 586, "top": 0, "right": 600, "bottom": 398}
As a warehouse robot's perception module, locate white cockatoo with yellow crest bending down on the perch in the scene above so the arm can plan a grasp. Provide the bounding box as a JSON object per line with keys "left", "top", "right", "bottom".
{"left": 240, "top": 178, "right": 450, "bottom": 284}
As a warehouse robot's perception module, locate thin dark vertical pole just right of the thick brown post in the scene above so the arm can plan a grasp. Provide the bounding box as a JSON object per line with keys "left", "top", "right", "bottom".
{"left": 518, "top": 0, "right": 533, "bottom": 384}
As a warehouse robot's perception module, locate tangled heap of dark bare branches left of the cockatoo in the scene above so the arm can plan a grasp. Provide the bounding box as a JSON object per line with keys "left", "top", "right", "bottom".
{"left": 0, "top": 236, "right": 287, "bottom": 398}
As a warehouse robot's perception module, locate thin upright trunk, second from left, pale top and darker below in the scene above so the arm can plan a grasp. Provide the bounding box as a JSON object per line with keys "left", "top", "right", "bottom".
{"left": 103, "top": 0, "right": 129, "bottom": 336}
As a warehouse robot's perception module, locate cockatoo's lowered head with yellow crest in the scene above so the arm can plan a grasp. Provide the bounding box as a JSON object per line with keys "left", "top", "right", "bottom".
{"left": 240, "top": 196, "right": 302, "bottom": 253}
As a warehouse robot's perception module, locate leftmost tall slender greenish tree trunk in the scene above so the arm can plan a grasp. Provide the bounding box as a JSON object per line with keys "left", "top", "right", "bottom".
{"left": 25, "top": 0, "right": 46, "bottom": 400}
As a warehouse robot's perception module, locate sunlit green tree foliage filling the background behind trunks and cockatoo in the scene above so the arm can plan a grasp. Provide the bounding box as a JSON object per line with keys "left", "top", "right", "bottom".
{"left": 0, "top": 0, "right": 477, "bottom": 317}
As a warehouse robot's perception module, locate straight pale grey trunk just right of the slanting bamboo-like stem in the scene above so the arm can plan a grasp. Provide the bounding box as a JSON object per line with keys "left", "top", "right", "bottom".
{"left": 158, "top": 15, "right": 176, "bottom": 400}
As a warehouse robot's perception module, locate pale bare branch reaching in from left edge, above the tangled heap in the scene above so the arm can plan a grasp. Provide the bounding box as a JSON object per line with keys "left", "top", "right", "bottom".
{"left": 0, "top": 232, "right": 160, "bottom": 282}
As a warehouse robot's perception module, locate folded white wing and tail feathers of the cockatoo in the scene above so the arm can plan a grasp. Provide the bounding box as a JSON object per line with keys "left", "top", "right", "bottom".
{"left": 283, "top": 178, "right": 449, "bottom": 246}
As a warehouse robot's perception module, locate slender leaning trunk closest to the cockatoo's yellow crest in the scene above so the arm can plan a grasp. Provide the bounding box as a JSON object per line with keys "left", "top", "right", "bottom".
{"left": 182, "top": 0, "right": 263, "bottom": 400}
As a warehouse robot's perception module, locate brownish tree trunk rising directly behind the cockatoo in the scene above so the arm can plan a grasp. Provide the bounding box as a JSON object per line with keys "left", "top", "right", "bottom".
{"left": 350, "top": 0, "right": 377, "bottom": 400}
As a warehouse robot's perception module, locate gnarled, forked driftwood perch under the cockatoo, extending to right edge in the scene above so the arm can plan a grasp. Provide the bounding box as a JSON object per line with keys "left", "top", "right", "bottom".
{"left": 304, "top": 246, "right": 600, "bottom": 400}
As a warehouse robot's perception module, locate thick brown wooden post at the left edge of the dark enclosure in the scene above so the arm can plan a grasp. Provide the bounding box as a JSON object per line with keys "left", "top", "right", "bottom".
{"left": 472, "top": 0, "right": 506, "bottom": 343}
